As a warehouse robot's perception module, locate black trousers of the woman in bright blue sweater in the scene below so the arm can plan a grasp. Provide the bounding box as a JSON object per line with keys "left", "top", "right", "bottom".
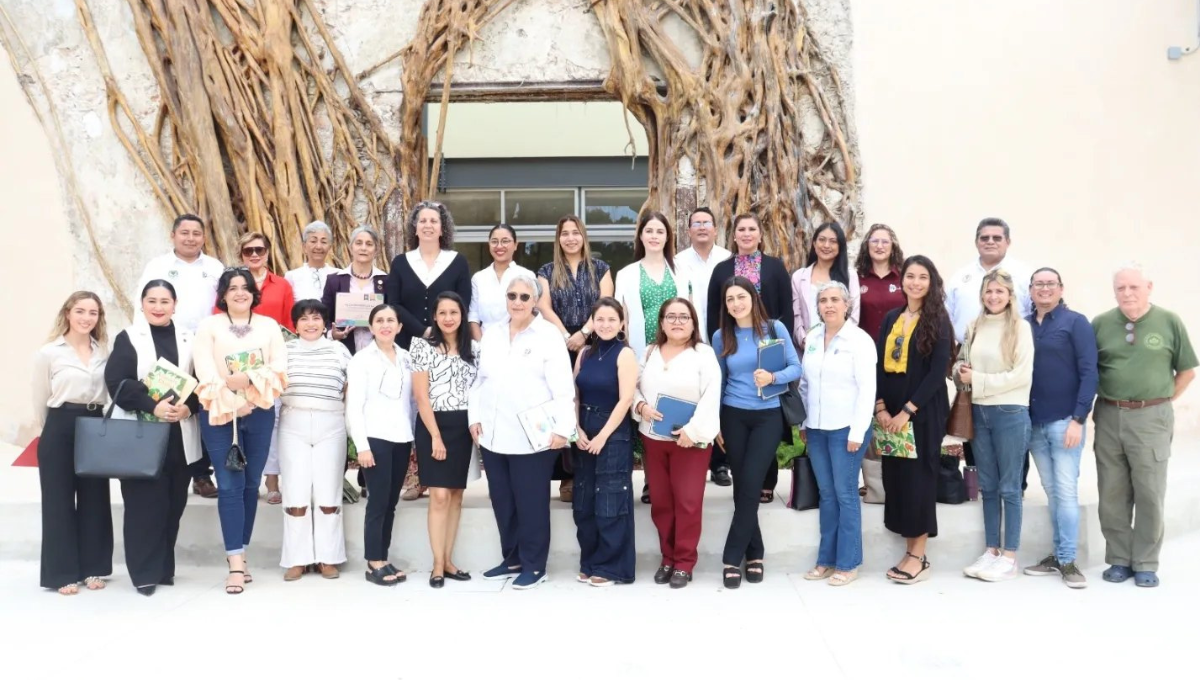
{"left": 721, "top": 407, "right": 784, "bottom": 566}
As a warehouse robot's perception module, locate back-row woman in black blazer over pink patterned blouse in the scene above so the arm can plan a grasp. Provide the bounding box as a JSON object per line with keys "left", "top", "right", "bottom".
{"left": 708, "top": 213, "right": 793, "bottom": 503}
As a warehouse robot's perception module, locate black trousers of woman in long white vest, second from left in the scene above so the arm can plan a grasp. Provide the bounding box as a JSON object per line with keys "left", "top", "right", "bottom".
{"left": 121, "top": 423, "right": 191, "bottom": 586}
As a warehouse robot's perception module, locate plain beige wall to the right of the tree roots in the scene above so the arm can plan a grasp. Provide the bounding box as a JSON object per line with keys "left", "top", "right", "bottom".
{"left": 852, "top": 0, "right": 1200, "bottom": 429}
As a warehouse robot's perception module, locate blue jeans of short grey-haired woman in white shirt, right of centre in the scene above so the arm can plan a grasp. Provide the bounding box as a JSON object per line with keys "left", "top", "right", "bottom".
{"left": 806, "top": 427, "right": 871, "bottom": 571}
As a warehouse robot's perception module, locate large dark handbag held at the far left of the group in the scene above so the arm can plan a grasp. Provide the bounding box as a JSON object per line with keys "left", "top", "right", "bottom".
{"left": 74, "top": 380, "right": 170, "bottom": 480}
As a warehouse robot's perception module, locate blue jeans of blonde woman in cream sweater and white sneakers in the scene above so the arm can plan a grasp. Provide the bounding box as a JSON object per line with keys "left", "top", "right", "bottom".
{"left": 971, "top": 404, "right": 1031, "bottom": 552}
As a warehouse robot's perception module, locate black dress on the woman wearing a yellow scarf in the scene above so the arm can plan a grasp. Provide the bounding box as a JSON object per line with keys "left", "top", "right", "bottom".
{"left": 880, "top": 373, "right": 946, "bottom": 538}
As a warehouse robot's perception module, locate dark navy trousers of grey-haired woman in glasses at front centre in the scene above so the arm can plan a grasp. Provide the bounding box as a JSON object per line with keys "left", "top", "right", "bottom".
{"left": 480, "top": 447, "right": 556, "bottom": 573}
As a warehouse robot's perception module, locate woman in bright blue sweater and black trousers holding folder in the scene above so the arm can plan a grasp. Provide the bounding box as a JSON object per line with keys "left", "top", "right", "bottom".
{"left": 713, "top": 276, "right": 800, "bottom": 588}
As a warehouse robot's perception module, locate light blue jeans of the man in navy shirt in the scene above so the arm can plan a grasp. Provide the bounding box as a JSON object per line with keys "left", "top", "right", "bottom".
{"left": 1030, "top": 417, "right": 1087, "bottom": 564}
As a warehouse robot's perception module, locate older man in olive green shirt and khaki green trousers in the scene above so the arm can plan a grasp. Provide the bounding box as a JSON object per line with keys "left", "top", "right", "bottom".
{"left": 1092, "top": 265, "right": 1198, "bottom": 588}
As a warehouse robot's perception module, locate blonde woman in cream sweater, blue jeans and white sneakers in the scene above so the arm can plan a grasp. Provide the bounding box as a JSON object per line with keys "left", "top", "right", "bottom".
{"left": 953, "top": 269, "right": 1033, "bottom": 580}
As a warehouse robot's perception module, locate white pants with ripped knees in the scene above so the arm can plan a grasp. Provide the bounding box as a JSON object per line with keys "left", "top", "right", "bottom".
{"left": 280, "top": 407, "right": 346, "bottom": 568}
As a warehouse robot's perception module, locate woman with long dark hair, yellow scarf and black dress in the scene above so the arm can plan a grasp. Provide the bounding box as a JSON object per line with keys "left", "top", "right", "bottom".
{"left": 875, "top": 255, "right": 954, "bottom": 584}
